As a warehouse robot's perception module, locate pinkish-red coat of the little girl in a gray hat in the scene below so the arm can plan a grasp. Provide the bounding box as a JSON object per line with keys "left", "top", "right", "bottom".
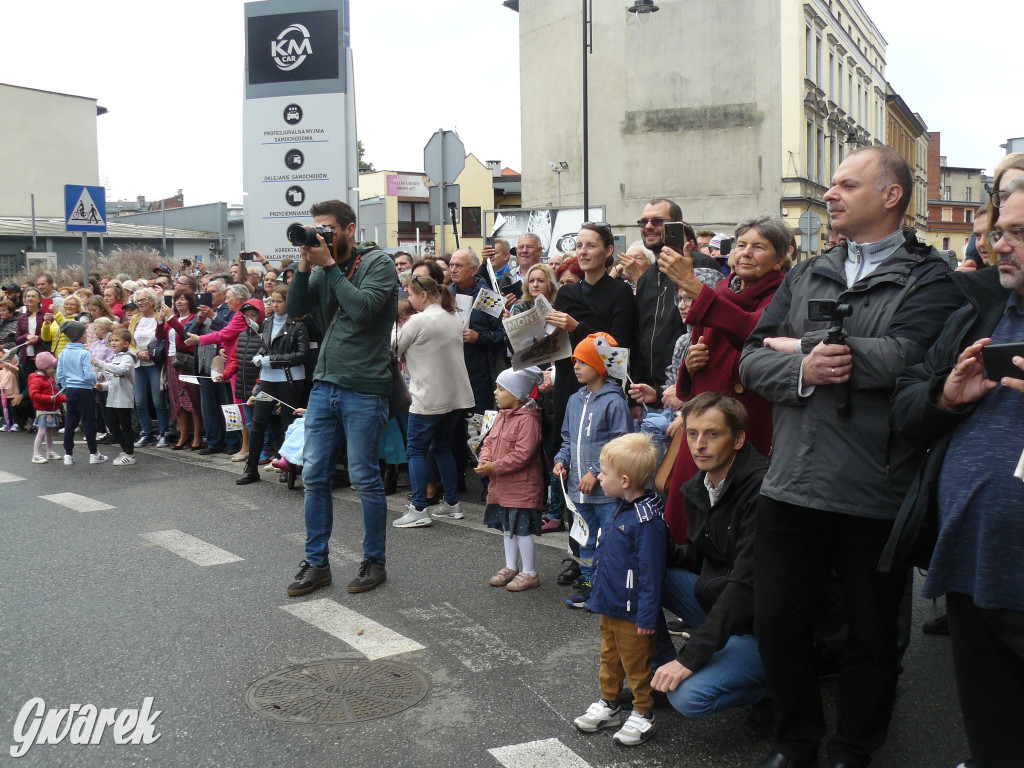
{"left": 480, "top": 400, "right": 544, "bottom": 509}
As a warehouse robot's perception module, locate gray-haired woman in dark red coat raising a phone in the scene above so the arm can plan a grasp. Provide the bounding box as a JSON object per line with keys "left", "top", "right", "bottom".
{"left": 652, "top": 216, "right": 793, "bottom": 544}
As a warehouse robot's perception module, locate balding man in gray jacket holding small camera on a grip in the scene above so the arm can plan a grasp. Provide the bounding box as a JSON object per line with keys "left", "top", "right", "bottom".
{"left": 739, "top": 146, "right": 962, "bottom": 768}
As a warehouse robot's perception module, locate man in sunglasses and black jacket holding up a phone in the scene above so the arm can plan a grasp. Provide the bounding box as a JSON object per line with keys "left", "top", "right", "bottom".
{"left": 630, "top": 198, "right": 721, "bottom": 421}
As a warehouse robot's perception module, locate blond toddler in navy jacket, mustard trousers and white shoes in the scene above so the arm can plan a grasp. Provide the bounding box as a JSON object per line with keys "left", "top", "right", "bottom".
{"left": 574, "top": 432, "right": 668, "bottom": 746}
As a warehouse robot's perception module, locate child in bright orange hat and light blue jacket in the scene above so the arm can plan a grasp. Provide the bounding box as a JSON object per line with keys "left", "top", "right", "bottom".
{"left": 552, "top": 333, "right": 632, "bottom": 608}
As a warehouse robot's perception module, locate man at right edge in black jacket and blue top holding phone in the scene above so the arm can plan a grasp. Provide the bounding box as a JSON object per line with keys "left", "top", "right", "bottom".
{"left": 884, "top": 177, "right": 1024, "bottom": 768}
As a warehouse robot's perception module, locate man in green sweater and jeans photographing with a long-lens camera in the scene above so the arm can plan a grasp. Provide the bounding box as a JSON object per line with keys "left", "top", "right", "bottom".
{"left": 288, "top": 200, "right": 398, "bottom": 597}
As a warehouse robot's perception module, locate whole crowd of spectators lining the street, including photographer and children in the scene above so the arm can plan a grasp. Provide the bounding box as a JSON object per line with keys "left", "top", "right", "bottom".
{"left": 0, "top": 147, "right": 1024, "bottom": 768}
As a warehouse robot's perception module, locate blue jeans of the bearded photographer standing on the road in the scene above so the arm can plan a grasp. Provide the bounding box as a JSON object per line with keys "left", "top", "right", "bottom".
{"left": 302, "top": 381, "right": 388, "bottom": 565}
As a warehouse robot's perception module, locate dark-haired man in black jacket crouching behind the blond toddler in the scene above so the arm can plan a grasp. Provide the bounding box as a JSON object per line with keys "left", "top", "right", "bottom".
{"left": 651, "top": 392, "right": 768, "bottom": 718}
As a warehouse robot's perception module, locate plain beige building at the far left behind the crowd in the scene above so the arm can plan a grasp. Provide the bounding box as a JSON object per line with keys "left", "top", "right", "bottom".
{"left": 0, "top": 83, "right": 106, "bottom": 219}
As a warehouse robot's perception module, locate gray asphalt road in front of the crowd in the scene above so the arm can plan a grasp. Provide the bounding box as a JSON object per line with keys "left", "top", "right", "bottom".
{"left": 0, "top": 434, "right": 967, "bottom": 768}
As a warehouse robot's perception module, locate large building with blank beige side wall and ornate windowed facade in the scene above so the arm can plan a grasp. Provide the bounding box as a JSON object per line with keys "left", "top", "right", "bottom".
{"left": 519, "top": 0, "right": 886, "bottom": 259}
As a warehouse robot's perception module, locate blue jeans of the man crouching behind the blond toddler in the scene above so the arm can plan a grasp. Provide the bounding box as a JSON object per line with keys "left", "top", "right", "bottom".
{"left": 653, "top": 568, "right": 768, "bottom": 718}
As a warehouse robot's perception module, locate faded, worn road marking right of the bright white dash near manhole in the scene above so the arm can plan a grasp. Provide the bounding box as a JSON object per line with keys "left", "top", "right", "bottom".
{"left": 401, "top": 603, "right": 531, "bottom": 672}
